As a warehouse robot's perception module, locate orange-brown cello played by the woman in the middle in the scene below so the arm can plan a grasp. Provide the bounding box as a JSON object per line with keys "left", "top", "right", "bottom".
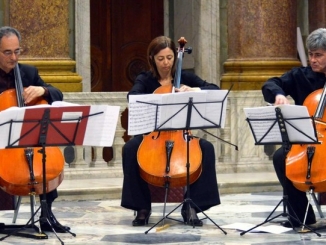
{"left": 137, "top": 37, "right": 202, "bottom": 187}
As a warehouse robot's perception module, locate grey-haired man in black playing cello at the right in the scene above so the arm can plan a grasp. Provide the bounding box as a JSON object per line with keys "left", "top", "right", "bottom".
{"left": 262, "top": 28, "right": 326, "bottom": 227}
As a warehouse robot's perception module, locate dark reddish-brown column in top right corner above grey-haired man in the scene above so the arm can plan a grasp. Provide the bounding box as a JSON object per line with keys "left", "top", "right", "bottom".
{"left": 308, "top": 0, "right": 326, "bottom": 32}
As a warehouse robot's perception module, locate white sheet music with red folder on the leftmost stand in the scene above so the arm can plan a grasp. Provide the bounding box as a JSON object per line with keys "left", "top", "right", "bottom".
{"left": 0, "top": 102, "right": 120, "bottom": 148}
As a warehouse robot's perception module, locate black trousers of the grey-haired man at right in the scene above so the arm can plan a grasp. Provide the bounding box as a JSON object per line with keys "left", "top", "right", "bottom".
{"left": 273, "top": 147, "right": 316, "bottom": 224}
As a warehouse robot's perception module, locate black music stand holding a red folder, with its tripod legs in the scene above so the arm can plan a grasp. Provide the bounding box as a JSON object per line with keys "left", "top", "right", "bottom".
{"left": 0, "top": 106, "right": 107, "bottom": 244}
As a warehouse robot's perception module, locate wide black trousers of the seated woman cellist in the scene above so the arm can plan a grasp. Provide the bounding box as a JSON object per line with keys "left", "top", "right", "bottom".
{"left": 121, "top": 136, "right": 220, "bottom": 212}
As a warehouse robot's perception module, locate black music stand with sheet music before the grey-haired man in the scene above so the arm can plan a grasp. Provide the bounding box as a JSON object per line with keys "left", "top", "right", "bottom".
{"left": 240, "top": 106, "right": 321, "bottom": 236}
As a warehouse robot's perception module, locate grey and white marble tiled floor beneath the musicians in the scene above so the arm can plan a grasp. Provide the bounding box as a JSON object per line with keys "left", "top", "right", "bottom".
{"left": 0, "top": 192, "right": 326, "bottom": 245}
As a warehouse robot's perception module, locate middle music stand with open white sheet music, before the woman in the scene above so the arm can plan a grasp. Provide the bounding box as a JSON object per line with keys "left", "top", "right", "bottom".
{"left": 128, "top": 90, "right": 229, "bottom": 234}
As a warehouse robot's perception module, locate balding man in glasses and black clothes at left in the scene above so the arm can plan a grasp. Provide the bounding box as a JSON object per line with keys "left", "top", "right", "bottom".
{"left": 0, "top": 26, "right": 70, "bottom": 233}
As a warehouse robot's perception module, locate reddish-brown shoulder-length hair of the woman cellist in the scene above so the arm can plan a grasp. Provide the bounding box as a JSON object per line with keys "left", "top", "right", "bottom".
{"left": 147, "top": 36, "right": 177, "bottom": 79}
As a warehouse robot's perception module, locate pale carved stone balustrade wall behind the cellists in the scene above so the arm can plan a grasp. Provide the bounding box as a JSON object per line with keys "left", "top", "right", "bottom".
{"left": 64, "top": 91, "right": 273, "bottom": 178}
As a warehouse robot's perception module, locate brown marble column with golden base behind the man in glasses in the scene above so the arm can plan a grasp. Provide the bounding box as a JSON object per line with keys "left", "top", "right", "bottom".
{"left": 5, "top": 0, "right": 82, "bottom": 92}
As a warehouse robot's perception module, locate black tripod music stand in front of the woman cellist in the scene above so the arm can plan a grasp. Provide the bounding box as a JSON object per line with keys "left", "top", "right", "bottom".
{"left": 129, "top": 90, "right": 229, "bottom": 234}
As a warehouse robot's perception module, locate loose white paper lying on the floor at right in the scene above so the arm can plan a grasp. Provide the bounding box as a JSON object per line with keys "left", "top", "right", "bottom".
{"left": 221, "top": 223, "right": 292, "bottom": 234}
